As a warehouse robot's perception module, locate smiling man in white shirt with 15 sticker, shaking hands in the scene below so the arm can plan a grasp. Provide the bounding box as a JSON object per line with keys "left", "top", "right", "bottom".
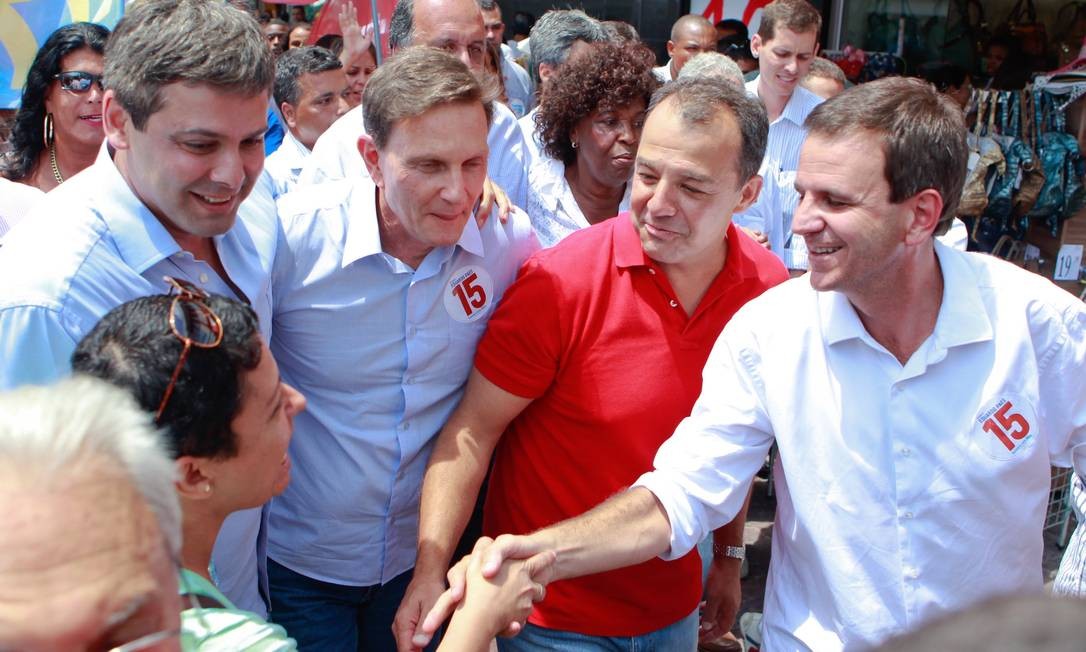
{"left": 434, "top": 78, "right": 1086, "bottom": 652}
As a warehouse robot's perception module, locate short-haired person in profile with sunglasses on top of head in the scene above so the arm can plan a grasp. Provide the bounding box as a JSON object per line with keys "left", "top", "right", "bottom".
{"left": 72, "top": 278, "right": 305, "bottom": 652}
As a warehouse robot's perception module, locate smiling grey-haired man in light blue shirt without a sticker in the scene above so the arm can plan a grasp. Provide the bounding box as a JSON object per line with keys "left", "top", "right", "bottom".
{"left": 0, "top": 0, "right": 278, "bottom": 615}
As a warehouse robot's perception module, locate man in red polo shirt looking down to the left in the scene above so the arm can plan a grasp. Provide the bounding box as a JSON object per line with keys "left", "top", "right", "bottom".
{"left": 400, "top": 79, "right": 787, "bottom": 650}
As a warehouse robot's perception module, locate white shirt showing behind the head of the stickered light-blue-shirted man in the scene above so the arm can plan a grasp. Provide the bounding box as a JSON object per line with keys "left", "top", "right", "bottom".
{"left": 298, "top": 102, "right": 528, "bottom": 206}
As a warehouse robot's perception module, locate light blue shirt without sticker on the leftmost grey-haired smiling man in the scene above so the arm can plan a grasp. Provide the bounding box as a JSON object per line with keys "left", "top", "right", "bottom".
{"left": 0, "top": 145, "right": 278, "bottom": 615}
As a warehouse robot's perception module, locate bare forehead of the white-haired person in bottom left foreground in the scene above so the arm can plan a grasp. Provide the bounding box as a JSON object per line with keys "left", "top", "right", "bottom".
{"left": 0, "top": 471, "right": 168, "bottom": 631}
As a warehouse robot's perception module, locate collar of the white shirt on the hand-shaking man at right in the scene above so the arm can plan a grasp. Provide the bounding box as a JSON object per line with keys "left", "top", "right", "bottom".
{"left": 819, "top": 241, "right": 992, "bottom": 350}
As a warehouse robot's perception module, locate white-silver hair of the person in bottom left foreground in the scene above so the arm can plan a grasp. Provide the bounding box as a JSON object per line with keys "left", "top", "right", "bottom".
{"left": 0, "top": 376, "right": 181, "bottom": 559}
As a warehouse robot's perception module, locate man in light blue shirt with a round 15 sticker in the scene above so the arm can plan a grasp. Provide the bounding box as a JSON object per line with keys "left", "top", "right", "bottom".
{"left": 268, "top": 46, "right": 539, "bottom": 652}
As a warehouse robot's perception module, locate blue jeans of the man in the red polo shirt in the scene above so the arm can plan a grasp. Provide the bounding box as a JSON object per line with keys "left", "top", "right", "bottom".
{"left": 497, "top": 611, "right": 698, "bottom": 652}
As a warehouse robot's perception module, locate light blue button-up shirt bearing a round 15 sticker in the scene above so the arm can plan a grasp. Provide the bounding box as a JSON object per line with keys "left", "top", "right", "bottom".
{"left": 268, "top": 179, "right": 539, "bottom": 586}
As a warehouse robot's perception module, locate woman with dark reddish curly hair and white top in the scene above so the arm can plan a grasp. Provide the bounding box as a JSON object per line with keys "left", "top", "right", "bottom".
{"left": 526, "top": 43, "right": 659, "bottom": 247}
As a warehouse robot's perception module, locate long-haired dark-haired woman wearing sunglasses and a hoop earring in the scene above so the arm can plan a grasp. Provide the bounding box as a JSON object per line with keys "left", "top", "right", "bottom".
{"left": 0, "top": 23, "right": 110, "bottom": 192}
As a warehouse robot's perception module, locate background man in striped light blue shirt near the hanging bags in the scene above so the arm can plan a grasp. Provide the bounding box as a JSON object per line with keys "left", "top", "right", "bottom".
{"left": 734, "top": 0, "right": 822, "bottom": 269}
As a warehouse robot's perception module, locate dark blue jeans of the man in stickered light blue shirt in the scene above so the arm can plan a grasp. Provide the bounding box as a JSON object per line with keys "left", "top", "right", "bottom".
{"left": 268, "top": 559, "right": 423, "bottom": 652}
